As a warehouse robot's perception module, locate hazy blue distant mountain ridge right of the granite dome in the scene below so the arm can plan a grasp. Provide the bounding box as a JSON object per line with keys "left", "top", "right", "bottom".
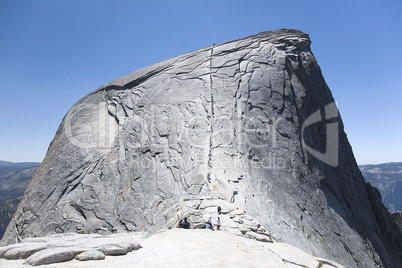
{"left": 359, "top": 162, "right": 402, "bottom": 212}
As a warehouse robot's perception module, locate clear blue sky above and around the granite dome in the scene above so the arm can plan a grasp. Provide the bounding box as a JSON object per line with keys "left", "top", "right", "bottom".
{"left": 0, "top": 0, "right": 402, "bottom": 164}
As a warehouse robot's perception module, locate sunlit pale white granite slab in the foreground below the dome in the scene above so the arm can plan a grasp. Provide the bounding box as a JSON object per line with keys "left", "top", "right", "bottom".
{"left": 0, "top": 228, "right": 344, "bottom": 268}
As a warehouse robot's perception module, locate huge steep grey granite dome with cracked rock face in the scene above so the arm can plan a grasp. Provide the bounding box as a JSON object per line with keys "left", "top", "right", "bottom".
{"left": 2, "top": 29, "right": 401, "bottom": 267}
